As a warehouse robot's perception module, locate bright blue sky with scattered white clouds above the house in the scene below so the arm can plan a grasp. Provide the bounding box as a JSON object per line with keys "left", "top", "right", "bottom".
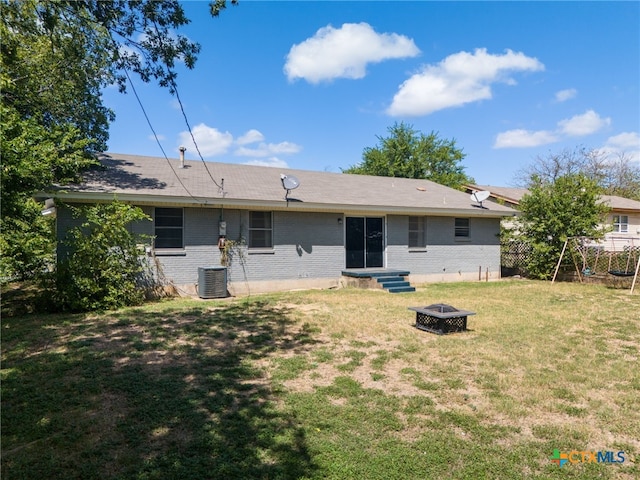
{"left": 104, "top": 0, "right": 640, "bottom": 186}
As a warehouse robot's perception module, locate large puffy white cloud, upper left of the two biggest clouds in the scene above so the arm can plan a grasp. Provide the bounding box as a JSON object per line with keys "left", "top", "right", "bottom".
{"left": 284, "top": 23, "right": 420, "bottom": 83}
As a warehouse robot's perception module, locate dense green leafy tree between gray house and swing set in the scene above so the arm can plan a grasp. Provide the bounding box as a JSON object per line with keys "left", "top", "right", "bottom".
{"left": 508, "top": 173, "right": 608, "bottom": 279}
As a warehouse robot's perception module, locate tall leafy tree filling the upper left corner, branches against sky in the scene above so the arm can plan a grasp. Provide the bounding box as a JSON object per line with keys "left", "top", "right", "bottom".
{"left": 0, "top": 0, "right": 237, "bottom": 277}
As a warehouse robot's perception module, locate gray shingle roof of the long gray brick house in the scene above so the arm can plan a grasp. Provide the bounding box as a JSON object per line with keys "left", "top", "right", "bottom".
{"left": 52, "top": 153, "right": 515, "bottom": 217}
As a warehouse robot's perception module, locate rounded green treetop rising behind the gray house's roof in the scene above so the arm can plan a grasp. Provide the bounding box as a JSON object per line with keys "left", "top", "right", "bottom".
{"left": 343, "top": 123, "right": 473, "bottom": 188}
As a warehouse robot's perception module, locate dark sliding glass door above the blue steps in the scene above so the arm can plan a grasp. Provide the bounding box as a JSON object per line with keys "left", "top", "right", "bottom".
{"left": 345, "top": 217, "right": 384, "bottom": 268}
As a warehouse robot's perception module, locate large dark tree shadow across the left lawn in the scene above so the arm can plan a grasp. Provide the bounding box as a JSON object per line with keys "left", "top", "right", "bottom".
{"left": 2, "top": 302, "right": 315, "bottom": 479}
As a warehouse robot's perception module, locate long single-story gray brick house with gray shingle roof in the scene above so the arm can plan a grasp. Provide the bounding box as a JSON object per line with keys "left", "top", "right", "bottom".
{"left": 47, "top": 153, "right": 514, "bottom": 295}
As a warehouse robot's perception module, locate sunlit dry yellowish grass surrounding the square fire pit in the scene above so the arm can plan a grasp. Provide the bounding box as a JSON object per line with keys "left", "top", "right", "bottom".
{"left": 262, "top": 282, "right": 640, "bottom": 473}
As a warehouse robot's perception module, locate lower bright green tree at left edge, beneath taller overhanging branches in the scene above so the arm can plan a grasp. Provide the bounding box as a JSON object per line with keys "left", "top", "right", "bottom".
{"left": 0, "top": 105, "right": 89, "bottom": 279}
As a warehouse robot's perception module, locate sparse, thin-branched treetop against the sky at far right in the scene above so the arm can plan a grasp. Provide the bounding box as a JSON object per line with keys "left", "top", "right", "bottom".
{"left": 516, "top": 147, "right": 640, "bottom": 200}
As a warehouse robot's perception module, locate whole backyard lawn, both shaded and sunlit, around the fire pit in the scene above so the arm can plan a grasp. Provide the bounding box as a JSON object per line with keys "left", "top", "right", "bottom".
{"left": 1, "top": 280, "right": 640, "bottom": 480}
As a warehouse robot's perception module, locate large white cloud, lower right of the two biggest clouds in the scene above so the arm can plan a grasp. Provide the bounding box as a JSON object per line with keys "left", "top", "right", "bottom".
{"left": 387, "top": 48, "right": 544, "bottom": 116}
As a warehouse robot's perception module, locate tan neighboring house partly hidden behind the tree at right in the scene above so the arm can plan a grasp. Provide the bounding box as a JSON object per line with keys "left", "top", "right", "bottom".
{"left": 466, "top": 185, "right": 640, "bottom": 250}
